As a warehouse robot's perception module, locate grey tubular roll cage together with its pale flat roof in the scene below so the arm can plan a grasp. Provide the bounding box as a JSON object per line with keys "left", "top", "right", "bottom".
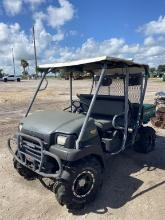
{"left": 25, "top": 56, "right": 149, "bottom": 154}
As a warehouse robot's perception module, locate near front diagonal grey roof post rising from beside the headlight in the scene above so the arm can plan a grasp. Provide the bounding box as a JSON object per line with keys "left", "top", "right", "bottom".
{"left": 76, "top": 63, "right": 107, "bottom": 150}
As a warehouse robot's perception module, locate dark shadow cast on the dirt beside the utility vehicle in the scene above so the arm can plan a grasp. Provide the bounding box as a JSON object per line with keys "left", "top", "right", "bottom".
{"left": 73, "top": 136, "right": 165, "bottom": 215}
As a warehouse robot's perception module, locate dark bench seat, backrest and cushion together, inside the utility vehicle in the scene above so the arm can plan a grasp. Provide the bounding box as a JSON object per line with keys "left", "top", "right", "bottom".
{"left": 77, "top": 94, "right": 125, "bottom": 132}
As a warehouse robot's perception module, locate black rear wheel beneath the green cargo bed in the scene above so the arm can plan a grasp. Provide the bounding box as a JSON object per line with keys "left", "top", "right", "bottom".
{"left": 134, "top": 127, "right": 156, "bottom": 153}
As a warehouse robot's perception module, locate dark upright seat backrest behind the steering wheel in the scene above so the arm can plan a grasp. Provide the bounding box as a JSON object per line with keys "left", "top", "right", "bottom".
{"left": 77, "top": 94, "right": 125, "bottom": 117}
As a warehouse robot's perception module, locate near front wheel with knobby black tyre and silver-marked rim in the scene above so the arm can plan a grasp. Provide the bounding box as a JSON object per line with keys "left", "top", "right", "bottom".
{"left": 53, "top": 158, "right": 102, "bottom": 210}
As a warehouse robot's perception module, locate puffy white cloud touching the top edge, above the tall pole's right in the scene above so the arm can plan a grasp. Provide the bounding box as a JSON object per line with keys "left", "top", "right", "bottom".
{"left": 47, "top": 0, "right": 75, "bottom": 28}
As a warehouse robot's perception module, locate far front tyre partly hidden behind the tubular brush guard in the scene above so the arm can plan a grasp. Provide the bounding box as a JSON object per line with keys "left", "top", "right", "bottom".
{"left": 13, "top": 158, "right": 37, "bottom": 180}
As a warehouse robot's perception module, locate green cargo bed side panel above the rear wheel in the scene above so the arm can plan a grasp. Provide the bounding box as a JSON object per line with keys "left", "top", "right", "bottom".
{"left": 143, "top": 104, "right": 156, "bottom": 124}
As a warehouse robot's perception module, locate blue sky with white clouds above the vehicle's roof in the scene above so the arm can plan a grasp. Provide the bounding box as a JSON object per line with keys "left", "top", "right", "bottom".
{"left": 0, "top": 0, "right": 165, "bottom": 74}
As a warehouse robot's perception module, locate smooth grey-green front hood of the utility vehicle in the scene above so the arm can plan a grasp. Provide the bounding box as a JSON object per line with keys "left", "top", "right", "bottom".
{"left": 21, "top": 111, "right": 85, "bottom": 135}
